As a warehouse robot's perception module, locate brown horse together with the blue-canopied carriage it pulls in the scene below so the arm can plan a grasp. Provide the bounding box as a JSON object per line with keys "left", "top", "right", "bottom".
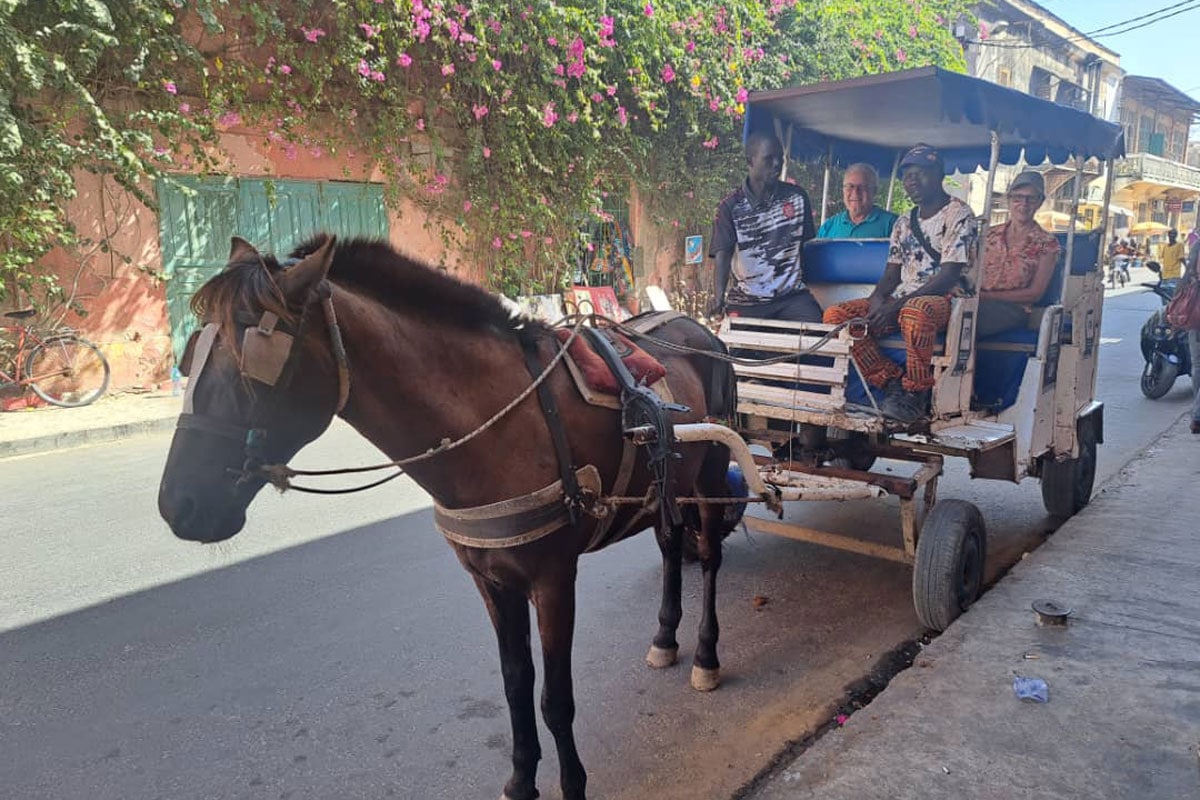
{"left": 158, "top": 70, "right": 1121, "bottom": 800}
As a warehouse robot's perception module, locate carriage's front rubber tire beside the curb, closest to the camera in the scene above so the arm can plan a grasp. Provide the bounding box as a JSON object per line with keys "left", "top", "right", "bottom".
{"left": 912, "top": 500, "right": 988, "bottom": 632}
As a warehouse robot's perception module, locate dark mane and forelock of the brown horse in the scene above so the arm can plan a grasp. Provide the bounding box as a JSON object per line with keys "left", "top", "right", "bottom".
{"left": 192, "top": 234, "right": 546, "bottom": 345}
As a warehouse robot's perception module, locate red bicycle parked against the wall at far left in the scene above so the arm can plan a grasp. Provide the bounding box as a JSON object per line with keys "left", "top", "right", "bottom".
{"left": 0, "top": 308, "right": 109, "bottom": 408}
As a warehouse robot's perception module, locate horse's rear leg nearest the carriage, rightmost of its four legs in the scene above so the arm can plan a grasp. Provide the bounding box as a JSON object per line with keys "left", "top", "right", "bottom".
{"left": 691, "top": 446, "right": 730, "bottom": 692}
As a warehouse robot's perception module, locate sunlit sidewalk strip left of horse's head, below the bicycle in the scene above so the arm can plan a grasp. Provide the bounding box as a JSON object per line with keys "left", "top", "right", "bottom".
{"left": 0, "top": 391, "right": 184, "bottom": 458}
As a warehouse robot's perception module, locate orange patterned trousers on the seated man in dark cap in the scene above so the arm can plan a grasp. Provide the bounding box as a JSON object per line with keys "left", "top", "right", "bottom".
{"left": 824, "top": 295, "right": 950, "bottom": 392}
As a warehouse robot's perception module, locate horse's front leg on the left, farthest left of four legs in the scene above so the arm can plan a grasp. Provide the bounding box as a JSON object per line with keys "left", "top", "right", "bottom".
{"left": 473, "top": 576, "right": 541, "bottom": 800}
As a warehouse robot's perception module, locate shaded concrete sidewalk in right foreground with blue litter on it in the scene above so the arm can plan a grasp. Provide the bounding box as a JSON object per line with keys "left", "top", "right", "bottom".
{"left": 742, "top": 420, "right": 1200, "bottom": 800}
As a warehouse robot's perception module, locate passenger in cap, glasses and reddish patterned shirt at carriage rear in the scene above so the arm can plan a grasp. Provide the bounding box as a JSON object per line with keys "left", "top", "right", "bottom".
{"left": 976, "top": 170, "right": 1061, "bottom": 337}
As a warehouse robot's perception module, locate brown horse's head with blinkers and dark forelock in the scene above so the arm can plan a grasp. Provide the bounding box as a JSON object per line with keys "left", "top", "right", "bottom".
{"left": 158, "top": 236, "right": 348, "bottom": 542}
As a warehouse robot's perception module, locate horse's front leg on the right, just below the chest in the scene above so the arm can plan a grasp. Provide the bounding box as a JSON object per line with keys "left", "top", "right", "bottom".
{"left": 530, "top": 564, "right": 588, "bottom": 800}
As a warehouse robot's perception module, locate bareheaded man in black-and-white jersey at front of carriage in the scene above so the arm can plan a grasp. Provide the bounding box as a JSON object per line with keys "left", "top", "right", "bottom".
{"left": 708, "top": 132, "right": 821, "bottom": 323}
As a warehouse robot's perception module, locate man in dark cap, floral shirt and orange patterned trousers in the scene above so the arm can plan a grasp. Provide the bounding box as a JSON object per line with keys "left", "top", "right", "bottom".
{"left": 824, "top": 144, "right": 978, "bottom": 422}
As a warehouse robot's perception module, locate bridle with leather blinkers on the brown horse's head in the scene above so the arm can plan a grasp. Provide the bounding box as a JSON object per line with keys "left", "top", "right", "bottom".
{"left": 176, "top": 279, "right": 350, "bottom": 488}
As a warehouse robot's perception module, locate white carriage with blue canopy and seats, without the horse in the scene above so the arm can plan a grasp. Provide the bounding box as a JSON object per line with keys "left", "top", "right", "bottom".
{"left": 700, "top": 67, "right": 1122, "bottom": 630}
